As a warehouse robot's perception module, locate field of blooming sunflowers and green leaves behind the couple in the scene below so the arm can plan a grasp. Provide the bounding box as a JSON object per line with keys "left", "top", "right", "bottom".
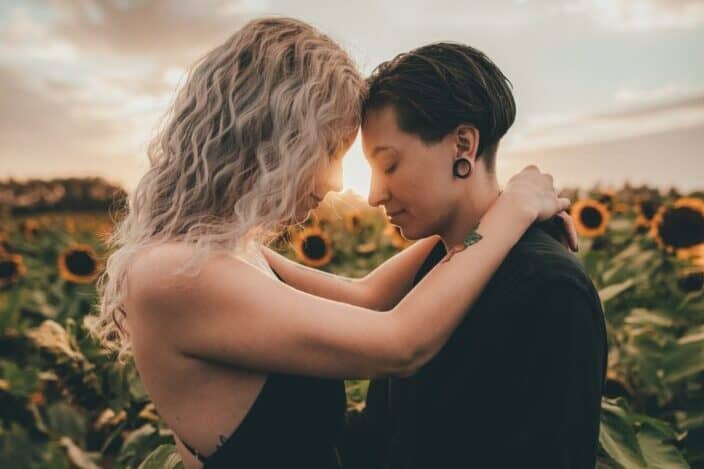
{"left": 0, "top": 180, "right": 704, "bottom": 468}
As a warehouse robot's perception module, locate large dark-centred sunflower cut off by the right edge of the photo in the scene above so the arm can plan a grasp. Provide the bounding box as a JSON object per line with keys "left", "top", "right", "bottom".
{"left": 650, "top": 197, "right": 704, "bottom": 255}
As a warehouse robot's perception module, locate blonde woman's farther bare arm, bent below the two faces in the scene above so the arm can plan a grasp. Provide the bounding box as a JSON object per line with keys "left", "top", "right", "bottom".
{"left": 262, "top": 236, "right": 440, "bottom": 311}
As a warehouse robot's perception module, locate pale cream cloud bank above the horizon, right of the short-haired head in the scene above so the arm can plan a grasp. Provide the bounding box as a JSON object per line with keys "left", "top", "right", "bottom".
{"left": 497, "top": 88, "right": 704, "bottom": 190}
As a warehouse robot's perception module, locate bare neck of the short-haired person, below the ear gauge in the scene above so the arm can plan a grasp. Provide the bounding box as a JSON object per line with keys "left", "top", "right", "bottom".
{"left": 438, "top": 174, "right": 500, "bottom": 251}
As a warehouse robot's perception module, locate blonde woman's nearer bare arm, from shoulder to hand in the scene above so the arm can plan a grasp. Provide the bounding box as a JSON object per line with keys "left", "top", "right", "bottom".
{"left": 129, "top": 166, "right": 569, "bottom": 378}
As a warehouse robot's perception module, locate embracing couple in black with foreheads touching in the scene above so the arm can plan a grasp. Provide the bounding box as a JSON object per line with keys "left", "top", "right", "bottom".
{"left": 93, "top": 18, "right": 607, "bottom": 469}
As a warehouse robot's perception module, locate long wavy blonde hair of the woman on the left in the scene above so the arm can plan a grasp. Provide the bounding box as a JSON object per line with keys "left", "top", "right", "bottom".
{"left": 86, "top": 17, "right": 365, "bottom": 365}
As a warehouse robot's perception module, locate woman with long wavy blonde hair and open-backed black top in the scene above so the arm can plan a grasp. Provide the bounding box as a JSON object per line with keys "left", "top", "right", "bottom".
{"left": 93, "top": 18, "right": 569, "bottom": 468}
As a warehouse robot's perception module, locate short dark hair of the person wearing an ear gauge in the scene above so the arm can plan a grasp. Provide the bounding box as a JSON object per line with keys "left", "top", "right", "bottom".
{"left": 362, "top": 42, "right": 516, "bottom": 171}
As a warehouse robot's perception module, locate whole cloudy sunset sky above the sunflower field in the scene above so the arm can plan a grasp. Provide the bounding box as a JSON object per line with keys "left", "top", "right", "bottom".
{"left": 0, "top": 0, "right": 704, "bottom": 196}
